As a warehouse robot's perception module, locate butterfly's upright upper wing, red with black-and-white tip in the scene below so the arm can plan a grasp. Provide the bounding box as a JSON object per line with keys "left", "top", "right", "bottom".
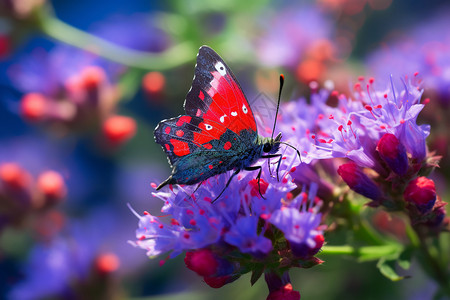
{"left": 184, "top": 46, "right": 257, "bottom": 139}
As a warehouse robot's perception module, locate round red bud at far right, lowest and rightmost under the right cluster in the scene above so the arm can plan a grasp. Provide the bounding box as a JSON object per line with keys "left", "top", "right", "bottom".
{"left": 403, "top": 177, "right": 436, "bottom": 213}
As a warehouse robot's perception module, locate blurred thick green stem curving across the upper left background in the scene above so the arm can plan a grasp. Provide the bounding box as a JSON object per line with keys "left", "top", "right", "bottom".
{"left": 37, "top": 7, "right": 197, "bottom": 71}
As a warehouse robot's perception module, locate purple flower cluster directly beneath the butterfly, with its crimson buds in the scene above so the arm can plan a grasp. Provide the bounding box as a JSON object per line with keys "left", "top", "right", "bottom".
{"left": 131, "top": 156, "right": 324, "bottom": 287}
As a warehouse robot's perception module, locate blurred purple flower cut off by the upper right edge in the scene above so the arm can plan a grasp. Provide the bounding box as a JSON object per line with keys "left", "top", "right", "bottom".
{"left": 366, "top": 11, "right": 450, "bottom": 104}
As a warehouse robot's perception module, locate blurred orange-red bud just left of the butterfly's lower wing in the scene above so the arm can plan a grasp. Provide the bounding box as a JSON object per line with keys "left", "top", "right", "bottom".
{"left": 103, "top": 116, "right": 136, "bottom": 145}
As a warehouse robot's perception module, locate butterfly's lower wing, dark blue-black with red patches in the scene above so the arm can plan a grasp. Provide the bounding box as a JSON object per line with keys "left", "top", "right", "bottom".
{"left": 155, "top": 116, "right": 255, "bottom": 189}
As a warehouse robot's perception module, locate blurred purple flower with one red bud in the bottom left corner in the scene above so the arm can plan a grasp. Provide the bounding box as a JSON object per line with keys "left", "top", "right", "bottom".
{"left": 9, "top": 208, "right": 143, "bottom": 299}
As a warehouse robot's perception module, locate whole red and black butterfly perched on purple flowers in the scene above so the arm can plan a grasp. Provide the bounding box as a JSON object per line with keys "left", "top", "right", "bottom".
{"left": 154, "top": 46, "right": 298, "bottom": 199}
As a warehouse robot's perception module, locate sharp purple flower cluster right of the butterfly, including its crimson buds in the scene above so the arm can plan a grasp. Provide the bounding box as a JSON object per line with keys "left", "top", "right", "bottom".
{"left": 279, "top": 76, "right": 445, "bottom": 227}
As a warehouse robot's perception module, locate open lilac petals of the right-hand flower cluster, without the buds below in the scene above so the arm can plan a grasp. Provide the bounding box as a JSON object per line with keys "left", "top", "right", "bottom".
{"left": 280, "top": 79, "right": 430, "bottom": 175}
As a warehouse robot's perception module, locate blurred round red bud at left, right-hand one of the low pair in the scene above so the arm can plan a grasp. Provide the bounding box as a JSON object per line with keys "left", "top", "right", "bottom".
{"left": 37, "top": 171, "right": 67, "bottom": 201}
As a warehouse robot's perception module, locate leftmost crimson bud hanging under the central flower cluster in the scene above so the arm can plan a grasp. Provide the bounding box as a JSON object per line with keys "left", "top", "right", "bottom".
{"left": 184, "top": 249, "right": 219, "bottom": 277}
